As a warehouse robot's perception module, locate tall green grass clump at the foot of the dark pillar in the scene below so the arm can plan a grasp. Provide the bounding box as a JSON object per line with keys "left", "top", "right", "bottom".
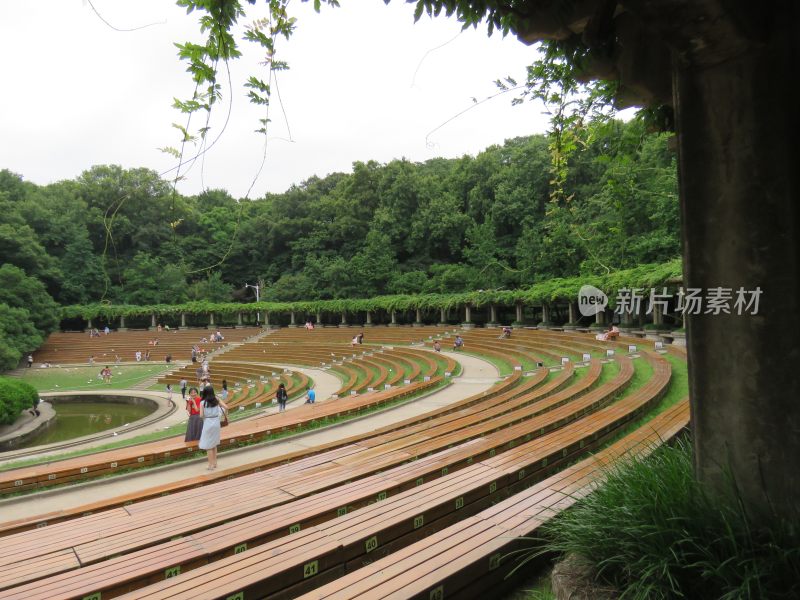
{"left": 541, "top": 440, "right": 800, "bottom": 600}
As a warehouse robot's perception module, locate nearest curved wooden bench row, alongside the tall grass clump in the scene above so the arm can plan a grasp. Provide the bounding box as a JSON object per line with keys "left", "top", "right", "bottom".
{"left": 296, "top": 401, "right": 689, "bottom": 600}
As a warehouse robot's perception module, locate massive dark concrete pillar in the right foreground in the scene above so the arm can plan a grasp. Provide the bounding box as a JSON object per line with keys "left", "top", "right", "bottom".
{"left": 673, "top": 21, "right": 800, "bottom": 526}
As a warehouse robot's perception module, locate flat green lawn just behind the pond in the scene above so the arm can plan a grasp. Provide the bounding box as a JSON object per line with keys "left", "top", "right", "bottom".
{"left": 14, "top": 363, "right": 175, "bottom": 392}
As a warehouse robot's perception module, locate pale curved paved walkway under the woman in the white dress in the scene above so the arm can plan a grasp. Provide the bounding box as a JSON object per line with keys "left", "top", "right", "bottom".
{"left": 0, "top": 353, "right": 498, "bottom": 521}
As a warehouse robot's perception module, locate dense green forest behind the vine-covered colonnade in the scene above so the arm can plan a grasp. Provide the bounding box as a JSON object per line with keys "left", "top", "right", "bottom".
{"left": 0, "top": 120, "right": 680, "bottom": 363}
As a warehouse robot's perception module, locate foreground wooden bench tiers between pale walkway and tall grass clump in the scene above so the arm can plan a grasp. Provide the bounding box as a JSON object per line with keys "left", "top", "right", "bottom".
{"left": 0, "top": 329, "right": 688, "bottom": 599}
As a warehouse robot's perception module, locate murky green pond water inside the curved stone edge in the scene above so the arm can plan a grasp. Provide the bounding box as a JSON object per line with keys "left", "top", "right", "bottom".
{"left": 18, "top": 401, "right": 155, "bottom": 448}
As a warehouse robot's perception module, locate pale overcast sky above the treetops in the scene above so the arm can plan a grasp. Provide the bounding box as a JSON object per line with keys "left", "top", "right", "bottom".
{"left": 0, "top": 0, "right": 547, "bottom": 198}
